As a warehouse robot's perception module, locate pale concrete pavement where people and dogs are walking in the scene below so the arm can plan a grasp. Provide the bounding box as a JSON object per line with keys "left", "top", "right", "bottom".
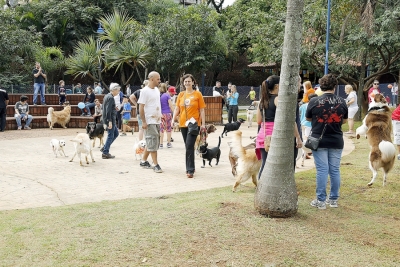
{"left": 0, "top": 123, "right": 354, "bottom": 213}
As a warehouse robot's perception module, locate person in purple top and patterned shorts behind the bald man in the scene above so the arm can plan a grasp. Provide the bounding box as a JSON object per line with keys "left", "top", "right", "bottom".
{"left": 160, "top": 83, "right": 176, "bottom": 148}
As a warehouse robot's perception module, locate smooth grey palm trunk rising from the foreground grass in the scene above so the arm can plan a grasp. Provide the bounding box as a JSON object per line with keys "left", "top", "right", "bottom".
{"left": 254, "top": 0, "right": 304, "bottom": 217}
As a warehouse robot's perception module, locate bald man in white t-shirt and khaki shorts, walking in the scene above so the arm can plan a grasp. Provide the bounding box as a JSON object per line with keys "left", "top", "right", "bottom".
{"left": 138, "top": 71, "right": 162, "bottom": 173}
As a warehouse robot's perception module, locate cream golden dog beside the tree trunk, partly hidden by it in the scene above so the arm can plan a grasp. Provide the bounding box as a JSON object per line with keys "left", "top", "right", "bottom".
{"left": 230, "top": 131, "right": 261, "bottom": 192}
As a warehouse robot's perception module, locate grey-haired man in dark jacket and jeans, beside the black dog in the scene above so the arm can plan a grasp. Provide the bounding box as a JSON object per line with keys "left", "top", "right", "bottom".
{"left": 100, "top": 83, "right": 121, "bottom": 159}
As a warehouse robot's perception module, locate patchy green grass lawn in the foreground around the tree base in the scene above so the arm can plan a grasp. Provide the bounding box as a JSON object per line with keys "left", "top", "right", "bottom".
{"left": 0, "top": 122, "right": 400, "bottom": 267}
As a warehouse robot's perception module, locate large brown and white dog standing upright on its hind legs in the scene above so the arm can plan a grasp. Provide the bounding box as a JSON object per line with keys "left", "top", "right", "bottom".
{"left": 356, "top": 94, "right": 396, "bottom": 186}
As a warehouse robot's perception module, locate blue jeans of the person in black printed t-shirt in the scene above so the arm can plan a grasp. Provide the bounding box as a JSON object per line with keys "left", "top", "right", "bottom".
{"left": 313, "top": 148, "right": 343, "bottom": 201}
